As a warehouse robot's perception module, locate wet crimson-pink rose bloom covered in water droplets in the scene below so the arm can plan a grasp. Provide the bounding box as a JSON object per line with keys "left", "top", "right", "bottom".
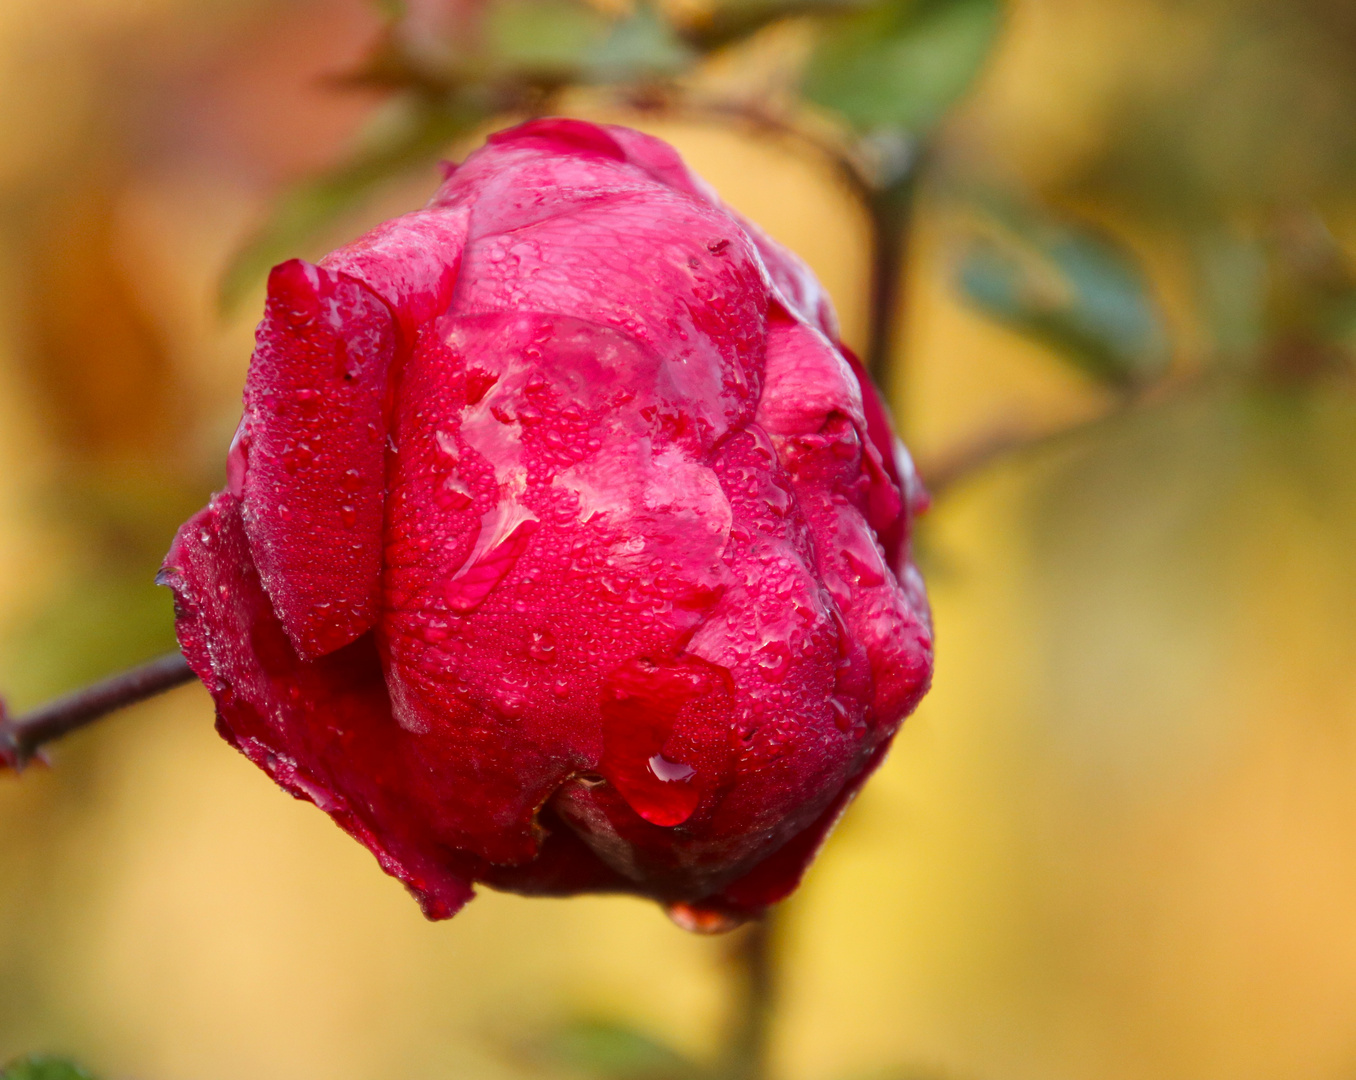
{"left": 164, "top": 119, "right": 932, "bottom": 925}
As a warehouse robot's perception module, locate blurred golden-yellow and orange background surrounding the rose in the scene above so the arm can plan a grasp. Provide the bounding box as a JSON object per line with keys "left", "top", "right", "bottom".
{"left": 0, "top": 0, "right": 1356, "bottom": 1080}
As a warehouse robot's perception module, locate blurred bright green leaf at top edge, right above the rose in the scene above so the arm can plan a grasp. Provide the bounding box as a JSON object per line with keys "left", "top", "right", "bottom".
{"left": 801, "top": 0, "right": 1002, "bottom": 136}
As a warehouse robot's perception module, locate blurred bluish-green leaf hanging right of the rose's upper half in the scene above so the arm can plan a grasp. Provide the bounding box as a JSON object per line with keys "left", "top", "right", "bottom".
{"left": 960, "top": 212, "right": 1168, "bottom": 387}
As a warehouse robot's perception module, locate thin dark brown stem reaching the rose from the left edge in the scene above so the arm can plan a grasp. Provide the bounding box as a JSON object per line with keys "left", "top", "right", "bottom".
{"left": 0, "top": 653, "right": 194, "bottom": 771}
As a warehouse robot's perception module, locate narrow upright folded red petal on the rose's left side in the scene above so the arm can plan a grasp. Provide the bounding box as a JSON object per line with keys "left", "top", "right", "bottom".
{"left": 232, "top": 259, "right": 395, "bottom": 657}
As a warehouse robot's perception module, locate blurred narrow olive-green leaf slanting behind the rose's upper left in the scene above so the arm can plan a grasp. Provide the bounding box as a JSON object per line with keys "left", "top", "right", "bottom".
{"left": 220, "top": 96, "right": 485, "bottom": 312}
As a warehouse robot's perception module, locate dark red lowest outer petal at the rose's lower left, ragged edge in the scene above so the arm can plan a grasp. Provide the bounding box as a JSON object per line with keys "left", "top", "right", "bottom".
{"left": 160, "top": 494, "right": 472, "bottom": 919}
